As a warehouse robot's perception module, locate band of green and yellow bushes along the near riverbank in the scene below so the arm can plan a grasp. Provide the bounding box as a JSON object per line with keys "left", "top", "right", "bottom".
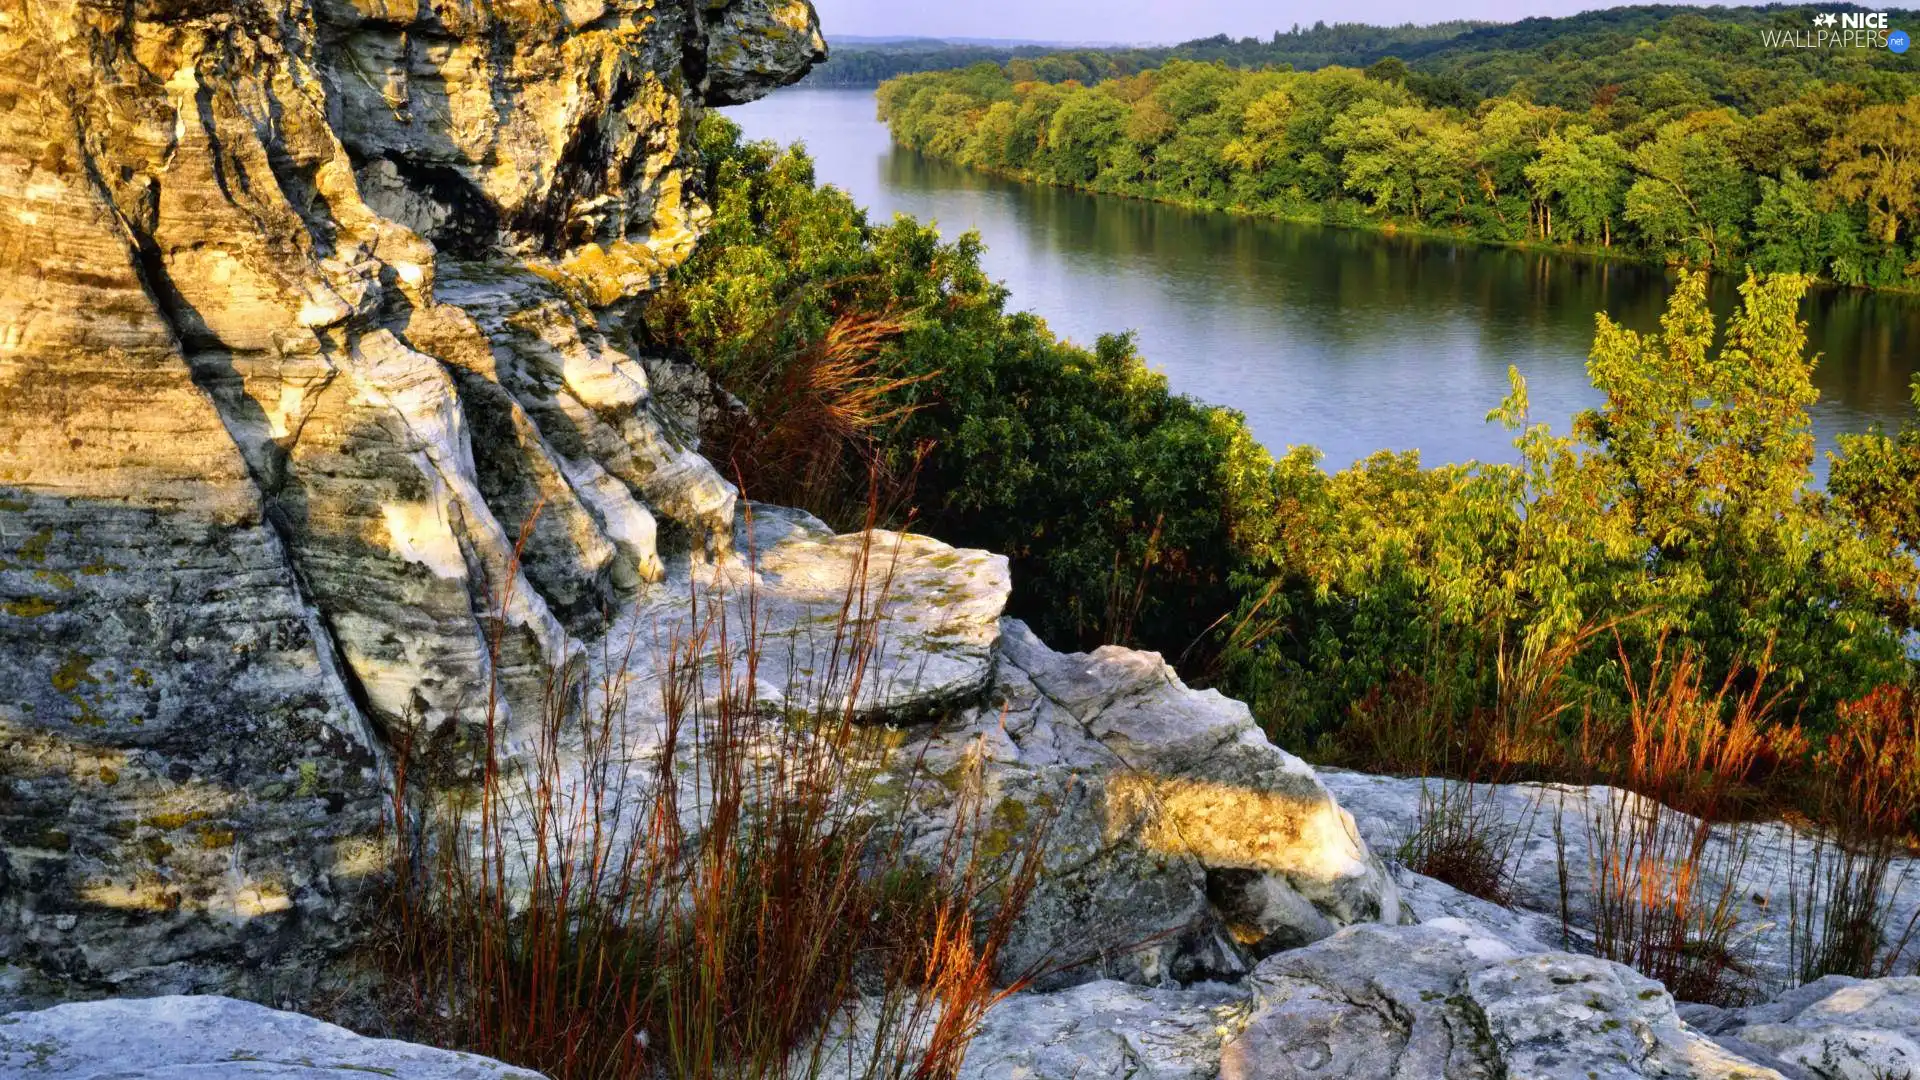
{"left": 641, "top": 113, "right": 1920, "bottom": 768}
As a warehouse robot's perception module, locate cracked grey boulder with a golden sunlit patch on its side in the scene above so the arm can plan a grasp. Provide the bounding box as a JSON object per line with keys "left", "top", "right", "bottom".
{"left": 893, "top": 619, "right": 1400, "bottom": 986}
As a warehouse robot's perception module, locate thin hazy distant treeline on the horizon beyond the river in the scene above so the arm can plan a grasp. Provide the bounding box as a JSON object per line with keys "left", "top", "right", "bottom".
{"left": 806, "top": 21, "right": 1494, "bottom": 86}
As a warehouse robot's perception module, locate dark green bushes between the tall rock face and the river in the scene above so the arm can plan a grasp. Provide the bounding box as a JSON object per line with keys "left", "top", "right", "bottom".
{"left": 643, "top": 115, "right": 1246, "bottom": 646}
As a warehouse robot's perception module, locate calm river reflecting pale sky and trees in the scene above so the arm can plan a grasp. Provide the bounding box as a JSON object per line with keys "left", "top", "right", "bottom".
{"left": 728, "top": 88, "right": 1920, "bottom": 477}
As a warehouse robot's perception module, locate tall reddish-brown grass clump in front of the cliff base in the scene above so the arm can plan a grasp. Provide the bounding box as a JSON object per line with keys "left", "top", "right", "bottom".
{"left": 388, "top": 522, "right": 1039, "bottom": 1080}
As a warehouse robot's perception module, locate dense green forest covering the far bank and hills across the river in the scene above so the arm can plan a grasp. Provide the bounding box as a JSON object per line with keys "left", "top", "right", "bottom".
{"left": 879, "top": 8, "right": 1920, "bottom": 286}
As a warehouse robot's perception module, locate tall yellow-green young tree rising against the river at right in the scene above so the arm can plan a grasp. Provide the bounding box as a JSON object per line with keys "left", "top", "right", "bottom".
{"left": 1574, "top": 273, "right": 1910, "bottom": 687}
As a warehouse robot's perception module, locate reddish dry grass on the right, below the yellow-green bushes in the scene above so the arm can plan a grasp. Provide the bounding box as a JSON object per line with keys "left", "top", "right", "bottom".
{"left": 1334, "top": 628, "right": 1920, "bottom": 1003}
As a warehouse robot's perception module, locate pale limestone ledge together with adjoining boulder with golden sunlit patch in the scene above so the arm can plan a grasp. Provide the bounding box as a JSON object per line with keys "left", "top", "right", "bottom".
{"left": 491, "top": 568, "right": 1397, "bottom": 986}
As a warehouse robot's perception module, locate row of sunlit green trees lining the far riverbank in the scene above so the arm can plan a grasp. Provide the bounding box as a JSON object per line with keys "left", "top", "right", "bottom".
{"left": 876, "top": 61, "right": 1920, "bottom": 292}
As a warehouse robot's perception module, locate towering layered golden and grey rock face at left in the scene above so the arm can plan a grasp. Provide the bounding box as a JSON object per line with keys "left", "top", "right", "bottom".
{"left": 0, "top": 0, "right": 824, "bottom": 997}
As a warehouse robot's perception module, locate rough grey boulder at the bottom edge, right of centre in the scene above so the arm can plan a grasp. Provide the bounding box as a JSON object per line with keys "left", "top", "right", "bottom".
{"left": 964, "top": 919, "right": 1782, "bottom": 1080}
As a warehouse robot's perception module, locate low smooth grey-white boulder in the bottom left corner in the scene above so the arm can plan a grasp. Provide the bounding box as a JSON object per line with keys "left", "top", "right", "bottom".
{"left": 0, "top": 997, "right": 540, "bottom": 1080}
